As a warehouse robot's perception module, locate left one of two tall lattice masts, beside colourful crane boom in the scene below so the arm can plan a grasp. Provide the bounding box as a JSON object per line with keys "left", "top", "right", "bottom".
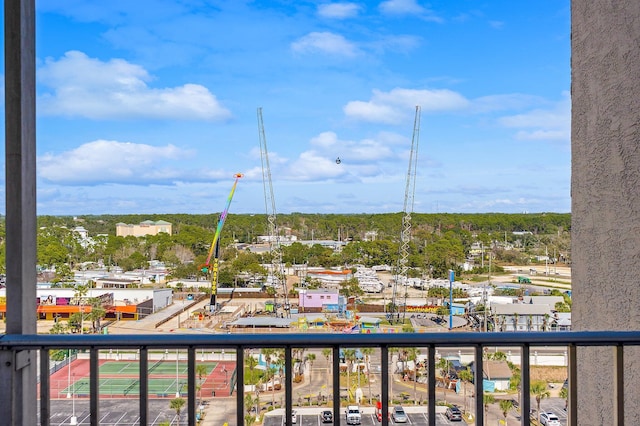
{"left": 258, "top": 108, "right": 290, "bottom": 316}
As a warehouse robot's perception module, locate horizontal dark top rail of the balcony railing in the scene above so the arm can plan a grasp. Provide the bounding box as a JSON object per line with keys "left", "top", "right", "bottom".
{"left": 0, "top": 331, "right": 640, "bottom": 350}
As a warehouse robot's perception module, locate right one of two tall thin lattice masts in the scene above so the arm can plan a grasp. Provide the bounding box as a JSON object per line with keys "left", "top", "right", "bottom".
{"left": 391, "top": 105, "right": 420, "bottom": 322}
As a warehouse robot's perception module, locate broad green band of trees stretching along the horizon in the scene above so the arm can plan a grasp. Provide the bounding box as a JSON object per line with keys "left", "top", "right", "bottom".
{"left": 0, "top": 213, "right": 571, "bottom": 285}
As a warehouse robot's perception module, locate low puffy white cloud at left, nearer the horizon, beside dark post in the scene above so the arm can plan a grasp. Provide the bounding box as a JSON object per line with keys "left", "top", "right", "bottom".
{"left": 38, "top": 140, "right": 191, "bottom": 185}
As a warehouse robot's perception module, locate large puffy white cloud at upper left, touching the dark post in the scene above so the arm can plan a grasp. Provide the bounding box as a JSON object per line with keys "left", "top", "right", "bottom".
{"left": 38, "top": 51, "right": 231, "bottom": 120}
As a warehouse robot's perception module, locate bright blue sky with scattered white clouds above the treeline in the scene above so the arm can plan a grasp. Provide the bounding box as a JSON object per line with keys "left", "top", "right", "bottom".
{"left": 0, "top": 0, "right": 571, "bottom": 215}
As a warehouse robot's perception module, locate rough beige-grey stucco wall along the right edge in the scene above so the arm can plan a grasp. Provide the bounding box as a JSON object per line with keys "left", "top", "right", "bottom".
{"left": 571, "top": 0, "right": 640, "bottom": 425}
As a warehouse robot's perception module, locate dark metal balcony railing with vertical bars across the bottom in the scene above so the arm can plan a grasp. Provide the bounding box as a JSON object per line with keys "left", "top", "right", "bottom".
{"left": 0, "top": 331, "right": 640, "bottom": 426}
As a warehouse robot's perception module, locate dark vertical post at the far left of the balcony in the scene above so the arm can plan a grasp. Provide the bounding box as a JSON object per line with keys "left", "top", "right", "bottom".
{"left": 0, "top": 0, "right": 37, "bottom": 425}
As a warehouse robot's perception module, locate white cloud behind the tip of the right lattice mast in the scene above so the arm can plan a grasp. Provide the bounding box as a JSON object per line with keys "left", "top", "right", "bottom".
{"left": 343, "top": 88, "right": 470, "bottom": 124}
